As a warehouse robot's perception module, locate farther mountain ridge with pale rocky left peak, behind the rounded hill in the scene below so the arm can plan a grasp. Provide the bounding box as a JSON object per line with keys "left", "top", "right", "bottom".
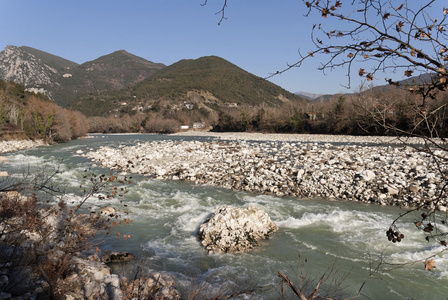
{"left": 0, "top": 46, "right": 165, "bottom": 106}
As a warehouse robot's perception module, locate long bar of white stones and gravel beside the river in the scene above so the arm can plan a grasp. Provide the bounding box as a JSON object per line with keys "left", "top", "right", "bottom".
{"left": 82, "top": 134, "right": 447, "bottom": 211}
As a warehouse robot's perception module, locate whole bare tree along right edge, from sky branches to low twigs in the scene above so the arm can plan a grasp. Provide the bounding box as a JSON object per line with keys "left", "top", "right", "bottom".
{"left": 204, "top": 0, "right": 448, "bottom": 276}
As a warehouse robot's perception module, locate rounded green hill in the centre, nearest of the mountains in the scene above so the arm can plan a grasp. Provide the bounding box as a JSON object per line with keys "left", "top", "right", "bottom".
{"left": 72, "top": 56, "right": 305, "bottom": 115}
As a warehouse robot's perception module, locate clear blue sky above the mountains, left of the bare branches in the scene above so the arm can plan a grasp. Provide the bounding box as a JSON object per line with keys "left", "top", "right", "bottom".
{"left": 0, "top": 0, "right": 376, "bottom": 94}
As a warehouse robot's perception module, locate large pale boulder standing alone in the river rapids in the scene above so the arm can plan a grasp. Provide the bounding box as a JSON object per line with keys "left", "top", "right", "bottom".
{"left": 199, "top": 206, "right": 278, "bottom": 253}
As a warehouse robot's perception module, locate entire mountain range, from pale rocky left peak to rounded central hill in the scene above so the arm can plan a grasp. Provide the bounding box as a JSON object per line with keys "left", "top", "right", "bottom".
{"left": 0, "top": 46, "right": 306, "bottom": 115}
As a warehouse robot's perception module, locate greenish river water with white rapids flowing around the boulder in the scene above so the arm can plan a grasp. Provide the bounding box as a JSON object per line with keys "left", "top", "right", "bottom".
{"left": 2, "top": 135, "right": 448, "bottom": 299}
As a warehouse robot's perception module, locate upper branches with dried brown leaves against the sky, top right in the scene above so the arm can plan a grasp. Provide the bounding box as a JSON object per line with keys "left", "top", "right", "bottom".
{"left": 272, "top": 0, "right": 448, "bottom": 100}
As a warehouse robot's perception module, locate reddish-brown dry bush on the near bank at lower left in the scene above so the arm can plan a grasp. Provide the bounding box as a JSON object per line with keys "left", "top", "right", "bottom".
{"left": 0, "top": 172, "right": 130, "bottom": 299}
